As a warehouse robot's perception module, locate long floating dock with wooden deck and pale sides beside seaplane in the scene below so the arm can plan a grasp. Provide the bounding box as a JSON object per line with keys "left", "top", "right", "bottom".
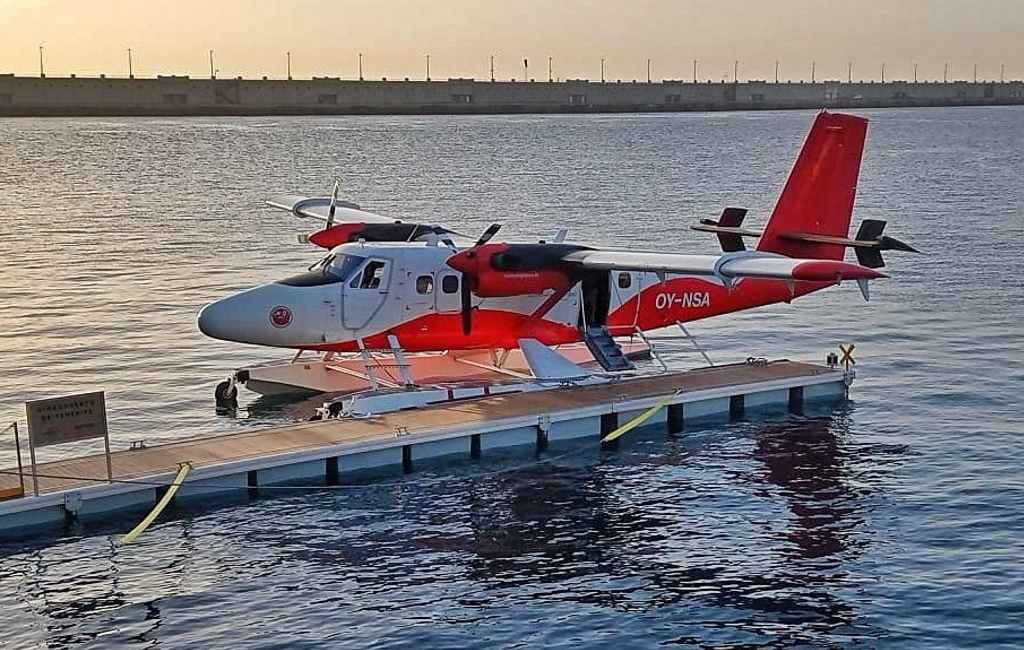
{"left": 0, "top": 360, "right": 850, "bottom": 538}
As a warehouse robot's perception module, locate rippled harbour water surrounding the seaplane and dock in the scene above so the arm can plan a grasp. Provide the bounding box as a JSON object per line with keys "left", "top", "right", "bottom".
{"left": 0, "top": 107, "right": 1024, "bottom": 648}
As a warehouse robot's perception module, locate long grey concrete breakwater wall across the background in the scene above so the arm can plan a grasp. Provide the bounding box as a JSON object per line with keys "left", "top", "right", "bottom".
{"left": 0, "top": 75, "right": 1024, "bottom": 117}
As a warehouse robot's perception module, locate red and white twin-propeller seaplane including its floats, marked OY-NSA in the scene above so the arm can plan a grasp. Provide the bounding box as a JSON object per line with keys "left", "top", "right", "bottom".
{"left": 198, "top": 112, "right": 915, "bottom": 405}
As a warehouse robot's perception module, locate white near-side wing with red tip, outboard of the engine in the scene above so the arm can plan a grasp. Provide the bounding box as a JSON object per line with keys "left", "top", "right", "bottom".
{"left": 564, "top": 250, "right": 887, "bottom": 283}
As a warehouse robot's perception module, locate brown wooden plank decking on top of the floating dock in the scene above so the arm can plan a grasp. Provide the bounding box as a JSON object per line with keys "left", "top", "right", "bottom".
{"left": 0, "top": 360, "right": 835, "bottom": 494}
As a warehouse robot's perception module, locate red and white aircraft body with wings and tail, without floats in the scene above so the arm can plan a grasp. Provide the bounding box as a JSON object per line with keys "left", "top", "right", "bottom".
{"left": 199, "top": 112, "right": 913, "bottom": 395}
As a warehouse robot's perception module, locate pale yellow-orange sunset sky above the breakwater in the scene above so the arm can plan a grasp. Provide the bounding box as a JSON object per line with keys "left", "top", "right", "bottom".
{"left": 0, "top": 0, "right": 1024, "bottom": 80}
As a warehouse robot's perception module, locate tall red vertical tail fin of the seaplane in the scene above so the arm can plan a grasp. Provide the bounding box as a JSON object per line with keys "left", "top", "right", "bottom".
{"left": 758, "top": 111, "right": 867, "bottom": 260}
